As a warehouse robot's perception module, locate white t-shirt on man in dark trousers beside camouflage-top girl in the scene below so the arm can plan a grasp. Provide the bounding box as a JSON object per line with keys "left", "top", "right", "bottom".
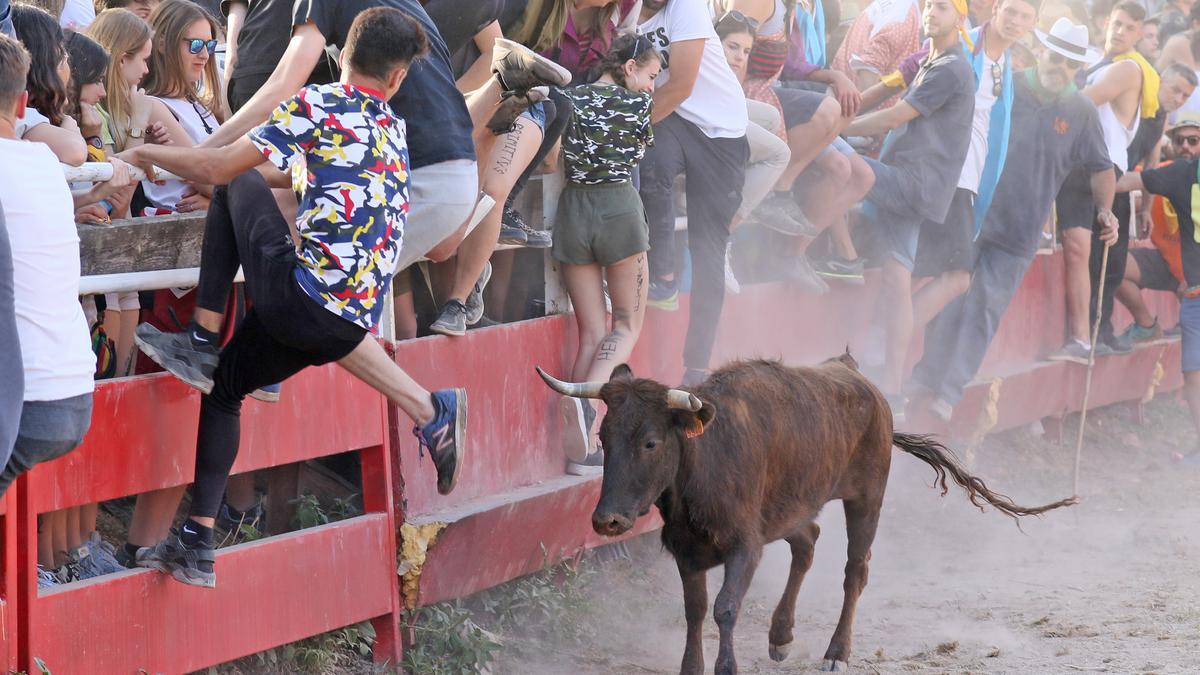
{"left": 637, "top": 0, "right": 748, "bottom": 138}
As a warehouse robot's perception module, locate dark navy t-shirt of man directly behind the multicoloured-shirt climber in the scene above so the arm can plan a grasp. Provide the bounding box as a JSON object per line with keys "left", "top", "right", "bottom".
{"left": 292, "top": 0, "right": 475, "bottom": 169}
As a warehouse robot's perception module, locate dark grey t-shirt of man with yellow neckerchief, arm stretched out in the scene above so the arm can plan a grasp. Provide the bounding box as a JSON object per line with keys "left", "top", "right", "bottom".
{"left": 880, "top": 43, "right": 976, "bottom": 222}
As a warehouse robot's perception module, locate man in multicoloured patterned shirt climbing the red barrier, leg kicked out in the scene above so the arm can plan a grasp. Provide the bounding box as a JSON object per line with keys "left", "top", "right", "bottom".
{"left": 115, "top": 7, "right": 467, "bottom": 587}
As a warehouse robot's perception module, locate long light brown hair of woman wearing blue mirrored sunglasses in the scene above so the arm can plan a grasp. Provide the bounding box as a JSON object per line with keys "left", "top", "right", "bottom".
{"left": 142, "top": 0, "right": 224, "bottom": 121}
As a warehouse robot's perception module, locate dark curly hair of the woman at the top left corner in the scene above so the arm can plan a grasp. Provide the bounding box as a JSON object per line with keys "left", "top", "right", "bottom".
{"left": 12, "top": 5, "right": 67, "bottom": 126}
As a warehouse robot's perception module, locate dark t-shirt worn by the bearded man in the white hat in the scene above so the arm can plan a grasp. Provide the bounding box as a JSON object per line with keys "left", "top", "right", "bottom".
{"left": 979, "top": 73, "right": 1112, "bottom": 256}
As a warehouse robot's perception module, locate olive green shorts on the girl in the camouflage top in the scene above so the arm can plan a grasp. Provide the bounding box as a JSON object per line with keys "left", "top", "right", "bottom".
{"left": 553, "top": 180, "right": 650, "bottom": 267}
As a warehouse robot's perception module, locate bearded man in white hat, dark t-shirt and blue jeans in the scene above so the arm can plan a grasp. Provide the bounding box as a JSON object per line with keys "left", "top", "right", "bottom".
{"left": 908, "top": 18, "right": 1117, "bottom": 422}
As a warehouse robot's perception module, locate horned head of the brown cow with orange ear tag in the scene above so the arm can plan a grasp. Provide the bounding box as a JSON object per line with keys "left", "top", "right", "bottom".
{"left": 538, "top": 365, "right": 716, "bottom": 537}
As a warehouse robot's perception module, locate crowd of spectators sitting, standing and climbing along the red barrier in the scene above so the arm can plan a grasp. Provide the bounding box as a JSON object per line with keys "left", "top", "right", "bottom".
{"left": 0, "top": 0, "right": 1200, "bottom": 585}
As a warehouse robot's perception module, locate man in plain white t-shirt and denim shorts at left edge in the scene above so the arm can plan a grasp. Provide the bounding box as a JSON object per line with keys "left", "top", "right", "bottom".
{"left": 0, "top": 37, "right": 131, "bottom": 583}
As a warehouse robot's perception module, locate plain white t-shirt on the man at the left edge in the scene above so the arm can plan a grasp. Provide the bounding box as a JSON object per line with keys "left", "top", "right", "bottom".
{"left": 0, "top": 138, "right": 96, "bottom": 401}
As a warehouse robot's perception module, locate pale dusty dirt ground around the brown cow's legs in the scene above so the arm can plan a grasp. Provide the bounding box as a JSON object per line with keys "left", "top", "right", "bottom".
{"left": 493, "top": 395, "right": 1200, "bottom": 675}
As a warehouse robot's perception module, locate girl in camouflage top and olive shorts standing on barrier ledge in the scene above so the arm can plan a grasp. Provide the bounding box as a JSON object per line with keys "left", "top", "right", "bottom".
{"left": 553, "top": 34, "right": 662, "bottom": 474}
